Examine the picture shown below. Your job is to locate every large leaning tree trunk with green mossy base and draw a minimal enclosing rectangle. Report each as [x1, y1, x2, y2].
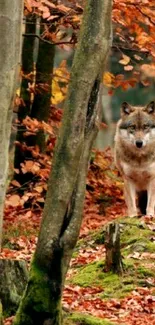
[14, 0, 112, 325]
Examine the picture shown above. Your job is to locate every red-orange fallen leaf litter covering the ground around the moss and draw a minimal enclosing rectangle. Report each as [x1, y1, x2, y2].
[0, 148, 155, 325]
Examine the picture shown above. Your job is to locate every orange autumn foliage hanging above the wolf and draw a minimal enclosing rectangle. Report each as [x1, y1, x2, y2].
[109, 0, 155, 90]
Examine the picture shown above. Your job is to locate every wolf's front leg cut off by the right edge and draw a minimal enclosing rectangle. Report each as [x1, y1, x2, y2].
[146, 180, 155, 216]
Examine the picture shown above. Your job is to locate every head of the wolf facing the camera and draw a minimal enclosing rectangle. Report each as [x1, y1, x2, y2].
[118, 102, 155, 150]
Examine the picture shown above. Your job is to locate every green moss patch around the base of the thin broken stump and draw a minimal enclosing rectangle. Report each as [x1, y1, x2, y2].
[70, 253, 155, 298]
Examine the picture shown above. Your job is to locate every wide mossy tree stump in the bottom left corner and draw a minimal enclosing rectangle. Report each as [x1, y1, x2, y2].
[0, 259, 28, 316]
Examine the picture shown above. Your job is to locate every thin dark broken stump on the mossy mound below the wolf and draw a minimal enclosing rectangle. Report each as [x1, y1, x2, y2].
[105, 222, 123, 274]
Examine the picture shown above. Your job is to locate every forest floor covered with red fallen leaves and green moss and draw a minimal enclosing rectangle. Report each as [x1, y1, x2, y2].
[0, 149, 155, 325]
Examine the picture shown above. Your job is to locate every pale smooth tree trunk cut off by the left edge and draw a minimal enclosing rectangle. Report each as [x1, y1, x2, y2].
[0, 0, 23, 246]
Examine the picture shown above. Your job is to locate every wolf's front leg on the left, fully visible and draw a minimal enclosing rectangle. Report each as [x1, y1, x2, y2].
[124, 179, 137, 217]
